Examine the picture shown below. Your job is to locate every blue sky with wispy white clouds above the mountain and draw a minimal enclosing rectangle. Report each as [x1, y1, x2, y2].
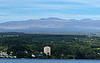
[0, 0, 100, 23]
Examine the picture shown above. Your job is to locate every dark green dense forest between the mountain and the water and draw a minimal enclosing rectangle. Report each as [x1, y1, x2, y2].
[0, 32, 100, 59]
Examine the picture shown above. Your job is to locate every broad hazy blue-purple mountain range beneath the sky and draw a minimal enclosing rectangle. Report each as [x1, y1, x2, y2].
[0, 17, 100, 33]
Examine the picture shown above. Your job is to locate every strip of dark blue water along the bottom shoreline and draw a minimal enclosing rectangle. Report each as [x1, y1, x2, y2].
[0, 59, 100, 63]
